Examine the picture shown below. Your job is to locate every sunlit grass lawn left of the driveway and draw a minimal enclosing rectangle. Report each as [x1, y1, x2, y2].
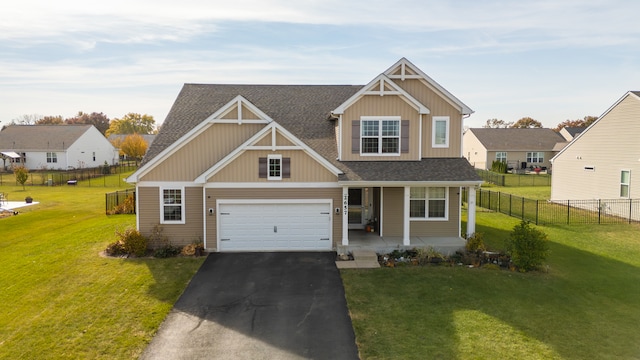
[0, 174, 204, 359]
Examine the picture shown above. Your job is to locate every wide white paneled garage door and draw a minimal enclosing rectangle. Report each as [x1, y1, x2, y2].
[218, 200, 332, 251]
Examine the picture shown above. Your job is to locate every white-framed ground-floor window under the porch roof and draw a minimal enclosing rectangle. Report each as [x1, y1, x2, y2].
[409, 187, 448, 220]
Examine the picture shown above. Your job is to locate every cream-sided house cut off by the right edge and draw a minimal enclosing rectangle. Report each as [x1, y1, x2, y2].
[551, 91, 640, 200]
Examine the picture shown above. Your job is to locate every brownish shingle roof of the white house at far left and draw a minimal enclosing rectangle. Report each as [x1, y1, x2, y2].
[0, 125, 93, 151]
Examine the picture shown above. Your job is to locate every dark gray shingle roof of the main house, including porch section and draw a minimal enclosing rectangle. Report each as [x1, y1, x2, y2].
[143, 84, 480, 181]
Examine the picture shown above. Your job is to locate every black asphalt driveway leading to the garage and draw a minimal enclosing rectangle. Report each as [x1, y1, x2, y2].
[141, 252, 358, 359]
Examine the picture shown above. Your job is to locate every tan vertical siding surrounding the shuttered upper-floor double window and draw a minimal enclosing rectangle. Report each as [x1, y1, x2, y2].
[342, 95, 420, 161]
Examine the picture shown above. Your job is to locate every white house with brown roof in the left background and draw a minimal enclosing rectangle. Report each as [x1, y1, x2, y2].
[0, 125, 118, 170]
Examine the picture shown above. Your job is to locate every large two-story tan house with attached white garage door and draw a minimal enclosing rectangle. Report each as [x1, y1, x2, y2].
[127, 58, 482, 251]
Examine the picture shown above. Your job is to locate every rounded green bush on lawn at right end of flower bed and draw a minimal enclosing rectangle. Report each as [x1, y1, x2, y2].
[505, 221, 549, 272]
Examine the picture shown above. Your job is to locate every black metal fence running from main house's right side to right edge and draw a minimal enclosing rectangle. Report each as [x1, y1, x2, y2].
[463, 189, 640, 225]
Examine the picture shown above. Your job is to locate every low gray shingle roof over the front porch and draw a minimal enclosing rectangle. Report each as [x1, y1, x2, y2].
[338, 158, 482, 184]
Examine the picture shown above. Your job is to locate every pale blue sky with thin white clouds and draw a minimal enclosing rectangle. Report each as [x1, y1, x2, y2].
[0, 0, 640, 127]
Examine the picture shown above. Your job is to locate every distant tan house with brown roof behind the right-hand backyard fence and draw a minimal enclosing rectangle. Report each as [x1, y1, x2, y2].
[462, 128, 564, 170]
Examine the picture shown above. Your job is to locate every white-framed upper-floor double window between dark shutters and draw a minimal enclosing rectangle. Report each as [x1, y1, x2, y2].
[360, 117, 400, 155]
